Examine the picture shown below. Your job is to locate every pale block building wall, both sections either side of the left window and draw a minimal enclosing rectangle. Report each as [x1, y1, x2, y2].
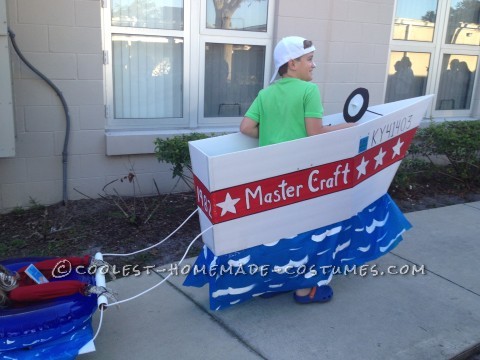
[0, 0, 402, 212]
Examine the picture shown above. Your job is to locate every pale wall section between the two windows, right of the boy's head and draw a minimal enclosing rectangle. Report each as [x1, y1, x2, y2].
[276, 0, 394, 114]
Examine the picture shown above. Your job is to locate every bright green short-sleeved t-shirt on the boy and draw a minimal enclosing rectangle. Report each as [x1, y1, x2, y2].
[245, 78, 323, 146]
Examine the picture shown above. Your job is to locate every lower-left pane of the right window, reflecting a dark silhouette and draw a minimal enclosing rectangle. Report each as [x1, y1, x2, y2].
[385, 51, 430, 102]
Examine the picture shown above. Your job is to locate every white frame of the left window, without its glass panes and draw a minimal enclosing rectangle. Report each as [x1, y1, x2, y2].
[102, 0, 275, 133]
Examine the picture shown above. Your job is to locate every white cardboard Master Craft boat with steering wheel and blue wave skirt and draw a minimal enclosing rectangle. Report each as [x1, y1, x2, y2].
[184, 93, 433, 310]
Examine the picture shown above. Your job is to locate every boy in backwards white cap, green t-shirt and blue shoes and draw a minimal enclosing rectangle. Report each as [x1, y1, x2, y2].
[240, 36, 353, 303]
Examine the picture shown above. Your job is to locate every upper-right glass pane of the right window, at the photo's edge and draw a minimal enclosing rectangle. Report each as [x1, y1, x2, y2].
[445, 0, 480, 46]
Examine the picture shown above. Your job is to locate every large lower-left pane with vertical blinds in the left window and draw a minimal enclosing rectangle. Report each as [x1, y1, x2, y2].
[112, 35, 183, 119]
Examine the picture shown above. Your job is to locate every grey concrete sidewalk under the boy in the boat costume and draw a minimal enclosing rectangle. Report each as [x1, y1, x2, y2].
[78, 202, 480, 360]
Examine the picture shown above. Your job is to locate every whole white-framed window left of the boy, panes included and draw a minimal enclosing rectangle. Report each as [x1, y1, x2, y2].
[103, 0, 274, 132]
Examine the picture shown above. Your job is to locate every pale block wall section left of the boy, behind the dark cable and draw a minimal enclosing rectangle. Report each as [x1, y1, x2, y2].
[0, 0, 182, 212]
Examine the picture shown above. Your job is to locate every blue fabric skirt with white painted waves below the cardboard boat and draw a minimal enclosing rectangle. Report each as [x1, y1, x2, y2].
[183, 194, 411, 310]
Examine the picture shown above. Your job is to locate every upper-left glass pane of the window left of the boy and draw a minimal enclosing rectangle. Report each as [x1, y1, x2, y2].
[112, 0, 183, 30]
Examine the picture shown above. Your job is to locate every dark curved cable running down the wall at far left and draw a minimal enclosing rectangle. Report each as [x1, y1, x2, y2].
[8, 28, 70, 205]
